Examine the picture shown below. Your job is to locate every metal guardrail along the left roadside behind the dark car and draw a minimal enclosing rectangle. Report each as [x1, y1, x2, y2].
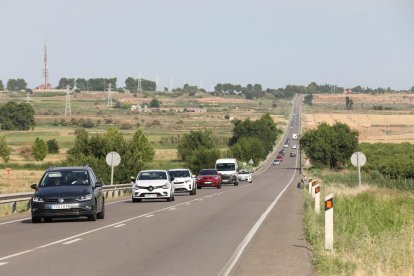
[0, 184, 132, 214]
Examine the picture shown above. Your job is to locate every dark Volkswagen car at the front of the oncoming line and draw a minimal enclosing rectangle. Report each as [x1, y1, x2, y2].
[30, 167, 105, 223]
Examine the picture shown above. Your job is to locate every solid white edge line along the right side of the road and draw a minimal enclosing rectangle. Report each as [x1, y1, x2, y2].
[219, 156, 298, 276]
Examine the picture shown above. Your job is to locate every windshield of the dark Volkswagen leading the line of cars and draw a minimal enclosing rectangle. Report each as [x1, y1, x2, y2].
[40, 170, 90, 187]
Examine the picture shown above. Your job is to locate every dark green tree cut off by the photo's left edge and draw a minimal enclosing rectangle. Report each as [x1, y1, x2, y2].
[0, 101, 35, 130]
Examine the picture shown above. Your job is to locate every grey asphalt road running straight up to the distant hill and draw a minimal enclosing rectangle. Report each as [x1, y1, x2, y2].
[0, 96, 311, 275]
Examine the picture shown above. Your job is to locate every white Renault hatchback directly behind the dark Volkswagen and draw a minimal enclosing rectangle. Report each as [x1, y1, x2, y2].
[131, 170, 175, 202]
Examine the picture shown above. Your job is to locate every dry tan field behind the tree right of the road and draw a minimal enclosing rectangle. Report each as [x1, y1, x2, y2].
[303, 94, 414, 143]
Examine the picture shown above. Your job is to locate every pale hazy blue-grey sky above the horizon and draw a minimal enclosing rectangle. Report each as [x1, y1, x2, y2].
[0, 0, 414, 90]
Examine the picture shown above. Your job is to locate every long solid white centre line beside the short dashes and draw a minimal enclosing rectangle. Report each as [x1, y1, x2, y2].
[0, 187, 251, 262]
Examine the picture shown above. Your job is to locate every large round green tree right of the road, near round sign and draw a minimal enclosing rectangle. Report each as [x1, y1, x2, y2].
[299, 122, 359, 169]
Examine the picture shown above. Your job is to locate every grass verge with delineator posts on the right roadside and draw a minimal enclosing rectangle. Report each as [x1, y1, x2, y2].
[305, 168, 414, 275]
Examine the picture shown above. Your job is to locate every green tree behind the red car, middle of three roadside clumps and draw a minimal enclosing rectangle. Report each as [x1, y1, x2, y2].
[177, 129, 216, 161]
